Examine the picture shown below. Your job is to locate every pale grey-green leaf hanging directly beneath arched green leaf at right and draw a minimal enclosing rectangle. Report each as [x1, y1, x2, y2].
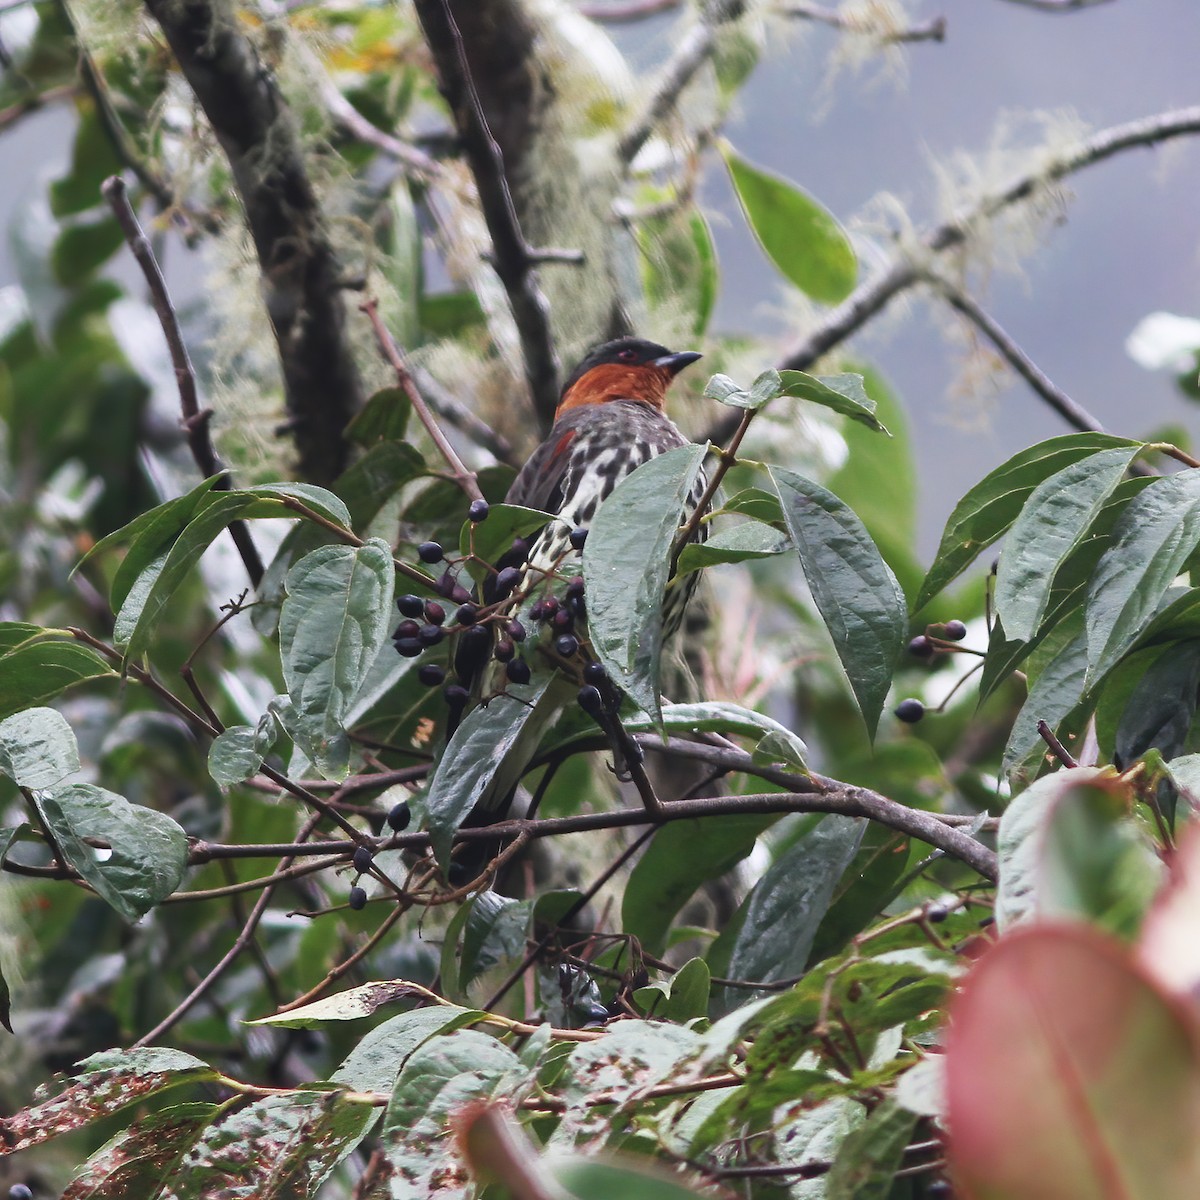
[995, 445, 1140, 641]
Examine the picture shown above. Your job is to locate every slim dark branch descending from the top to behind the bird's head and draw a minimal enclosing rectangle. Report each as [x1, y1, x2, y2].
[415, 0, 558, 424]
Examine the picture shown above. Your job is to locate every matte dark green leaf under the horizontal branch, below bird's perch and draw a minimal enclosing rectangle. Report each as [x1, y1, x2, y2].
[620, 814, 779, 955]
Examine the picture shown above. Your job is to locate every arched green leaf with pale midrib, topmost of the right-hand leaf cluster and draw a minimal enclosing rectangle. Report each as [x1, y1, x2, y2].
[914, 433, 1140, 610]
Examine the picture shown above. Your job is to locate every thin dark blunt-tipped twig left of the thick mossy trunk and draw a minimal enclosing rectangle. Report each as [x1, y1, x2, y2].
[100, 175, 263, 588]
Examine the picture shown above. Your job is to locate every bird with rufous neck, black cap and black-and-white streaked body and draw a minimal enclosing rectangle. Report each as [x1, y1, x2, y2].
[422, 337, 707, 866]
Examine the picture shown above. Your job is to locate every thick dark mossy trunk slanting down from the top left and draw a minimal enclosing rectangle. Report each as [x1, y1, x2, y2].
[145, 0, 362, 484]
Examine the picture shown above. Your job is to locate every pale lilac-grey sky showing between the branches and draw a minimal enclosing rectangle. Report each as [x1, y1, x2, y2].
[0, 0, 1200, 559]
